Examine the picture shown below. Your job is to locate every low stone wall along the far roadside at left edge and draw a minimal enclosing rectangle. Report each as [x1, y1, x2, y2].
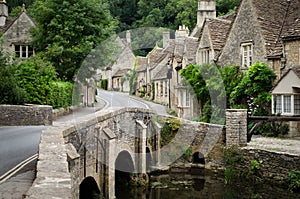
[0, 105, 53, 126]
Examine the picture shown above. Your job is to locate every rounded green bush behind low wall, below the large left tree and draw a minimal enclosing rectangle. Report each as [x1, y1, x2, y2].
[15, 57, 56, 105]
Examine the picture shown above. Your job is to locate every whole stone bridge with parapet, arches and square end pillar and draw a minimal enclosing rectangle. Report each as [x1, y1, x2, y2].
[27, 108, 247, 198]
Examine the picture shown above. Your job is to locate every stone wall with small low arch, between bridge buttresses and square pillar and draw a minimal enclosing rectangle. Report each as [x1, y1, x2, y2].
[161, 116, 225, 169]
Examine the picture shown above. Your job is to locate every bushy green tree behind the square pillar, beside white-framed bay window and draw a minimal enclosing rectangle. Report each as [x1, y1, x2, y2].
[230, 62, 276, 115]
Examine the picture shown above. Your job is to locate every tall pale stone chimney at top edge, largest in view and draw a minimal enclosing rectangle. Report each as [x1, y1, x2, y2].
[197, 0, 217, 27]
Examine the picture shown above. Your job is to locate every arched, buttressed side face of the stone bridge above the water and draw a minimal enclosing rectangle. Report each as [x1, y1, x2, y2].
[64, 108, 161, 198]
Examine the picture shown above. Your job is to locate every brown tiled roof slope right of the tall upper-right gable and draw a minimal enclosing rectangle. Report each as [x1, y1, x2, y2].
[252, 0, 300, 56]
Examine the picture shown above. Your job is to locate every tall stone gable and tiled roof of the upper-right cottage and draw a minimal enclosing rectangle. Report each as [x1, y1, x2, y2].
[217, 0, 300, 77]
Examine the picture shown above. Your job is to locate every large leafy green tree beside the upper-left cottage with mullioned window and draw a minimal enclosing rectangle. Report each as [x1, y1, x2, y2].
[32, 0, 116, 80]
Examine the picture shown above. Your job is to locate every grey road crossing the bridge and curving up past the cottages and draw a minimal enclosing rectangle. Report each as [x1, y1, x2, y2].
[0, 90, 165, 180]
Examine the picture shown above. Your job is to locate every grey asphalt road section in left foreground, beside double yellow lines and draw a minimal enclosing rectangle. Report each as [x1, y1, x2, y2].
[0, 126, 47, 176]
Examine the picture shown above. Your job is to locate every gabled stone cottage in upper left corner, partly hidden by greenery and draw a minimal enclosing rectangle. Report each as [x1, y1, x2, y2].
[0, 0, 36, 58]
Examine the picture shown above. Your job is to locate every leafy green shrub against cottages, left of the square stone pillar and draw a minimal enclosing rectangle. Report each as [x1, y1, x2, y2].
[180, 64, 226, 124]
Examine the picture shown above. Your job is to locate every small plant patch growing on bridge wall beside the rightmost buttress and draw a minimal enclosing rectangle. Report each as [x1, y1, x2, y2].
[160, 118, 180, 147]
